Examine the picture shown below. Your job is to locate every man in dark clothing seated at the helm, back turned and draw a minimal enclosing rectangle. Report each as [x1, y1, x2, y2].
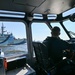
[43, 26, 71, 63]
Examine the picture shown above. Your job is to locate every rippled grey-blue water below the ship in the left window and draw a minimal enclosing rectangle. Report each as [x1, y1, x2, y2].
[0, 43, 27, 57]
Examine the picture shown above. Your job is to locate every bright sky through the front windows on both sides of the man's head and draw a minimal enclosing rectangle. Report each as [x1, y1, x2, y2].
[32, 20, 75, 41]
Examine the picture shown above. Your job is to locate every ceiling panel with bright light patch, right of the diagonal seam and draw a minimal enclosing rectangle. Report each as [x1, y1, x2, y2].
[33, 0, 75, 14]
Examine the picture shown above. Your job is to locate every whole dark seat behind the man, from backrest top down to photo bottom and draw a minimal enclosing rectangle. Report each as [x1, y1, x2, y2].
[33, 42, 55, 75]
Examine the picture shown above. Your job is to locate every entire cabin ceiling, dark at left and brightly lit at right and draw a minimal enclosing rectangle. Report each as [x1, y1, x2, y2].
[0, 0, 75, 14]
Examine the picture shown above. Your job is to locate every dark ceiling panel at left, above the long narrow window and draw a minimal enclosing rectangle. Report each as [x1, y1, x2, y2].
[0, 0, 35, 12]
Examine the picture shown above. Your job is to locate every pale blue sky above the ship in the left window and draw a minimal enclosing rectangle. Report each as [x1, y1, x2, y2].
[0, 21, 26, 38]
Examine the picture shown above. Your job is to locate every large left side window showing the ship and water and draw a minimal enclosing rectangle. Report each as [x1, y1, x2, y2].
[0, 21, 28, 58]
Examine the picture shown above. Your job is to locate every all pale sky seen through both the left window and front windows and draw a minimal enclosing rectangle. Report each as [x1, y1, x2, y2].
[0, 8, 75, 41]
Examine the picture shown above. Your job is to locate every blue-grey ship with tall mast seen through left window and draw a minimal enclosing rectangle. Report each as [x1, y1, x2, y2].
[0, 23, 26, 46]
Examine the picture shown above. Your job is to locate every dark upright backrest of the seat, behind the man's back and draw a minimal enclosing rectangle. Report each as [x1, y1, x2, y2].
[33, 42, 53, 70]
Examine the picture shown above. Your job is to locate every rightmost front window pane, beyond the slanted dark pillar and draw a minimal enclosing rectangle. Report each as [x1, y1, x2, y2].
[63, 20, 75, 38]
